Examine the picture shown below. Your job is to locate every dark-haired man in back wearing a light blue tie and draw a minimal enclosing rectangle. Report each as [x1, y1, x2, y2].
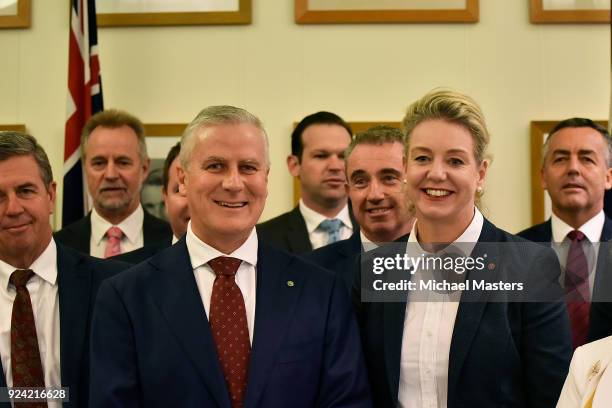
[257, 112, 357, 254]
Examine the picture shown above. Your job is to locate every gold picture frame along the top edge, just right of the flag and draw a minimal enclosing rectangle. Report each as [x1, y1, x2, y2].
[96, 0, 252, 27]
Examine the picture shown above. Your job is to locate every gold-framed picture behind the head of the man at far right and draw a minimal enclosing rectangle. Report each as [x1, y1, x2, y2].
[530, 120, 608, 225]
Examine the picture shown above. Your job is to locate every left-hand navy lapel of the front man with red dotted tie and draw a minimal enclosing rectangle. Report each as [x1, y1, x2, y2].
[149, 242, 231, 407]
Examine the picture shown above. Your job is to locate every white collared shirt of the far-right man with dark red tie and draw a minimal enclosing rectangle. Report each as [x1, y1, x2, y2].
[550, 210, 606, 295]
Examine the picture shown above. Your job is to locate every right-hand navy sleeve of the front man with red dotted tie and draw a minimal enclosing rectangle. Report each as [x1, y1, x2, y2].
[317, 276, 372, 408]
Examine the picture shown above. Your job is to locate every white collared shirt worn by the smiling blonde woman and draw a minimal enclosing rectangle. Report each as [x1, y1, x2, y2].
[398, 208, 484, 408]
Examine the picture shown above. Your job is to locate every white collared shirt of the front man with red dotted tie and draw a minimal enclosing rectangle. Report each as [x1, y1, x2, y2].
[186, 221, 259, 345]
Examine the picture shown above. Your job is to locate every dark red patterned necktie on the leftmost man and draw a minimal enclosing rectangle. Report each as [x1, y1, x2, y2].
[9, 269, 47, 408]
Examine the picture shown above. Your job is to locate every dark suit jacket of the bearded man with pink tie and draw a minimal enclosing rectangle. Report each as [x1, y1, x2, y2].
[53, 210, 172, 254]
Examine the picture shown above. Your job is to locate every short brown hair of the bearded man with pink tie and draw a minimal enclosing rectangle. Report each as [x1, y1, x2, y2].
[81, 109, 149, 163]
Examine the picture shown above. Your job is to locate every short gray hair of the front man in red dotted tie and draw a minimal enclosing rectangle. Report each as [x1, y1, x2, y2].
[179, 105, 270, 169]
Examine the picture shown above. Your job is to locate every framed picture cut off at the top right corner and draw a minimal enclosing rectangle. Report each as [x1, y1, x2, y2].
[530, 0, 610, 24]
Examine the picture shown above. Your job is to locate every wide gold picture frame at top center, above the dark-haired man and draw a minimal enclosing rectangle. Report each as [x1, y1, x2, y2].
[295, 0, 479, 24]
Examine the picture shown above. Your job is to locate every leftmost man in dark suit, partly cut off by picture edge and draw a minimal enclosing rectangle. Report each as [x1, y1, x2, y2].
[0, 132, 127, 407]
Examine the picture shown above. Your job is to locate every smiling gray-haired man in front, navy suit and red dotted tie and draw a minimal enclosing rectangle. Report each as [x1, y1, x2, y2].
[90, 106, 371, 408]
